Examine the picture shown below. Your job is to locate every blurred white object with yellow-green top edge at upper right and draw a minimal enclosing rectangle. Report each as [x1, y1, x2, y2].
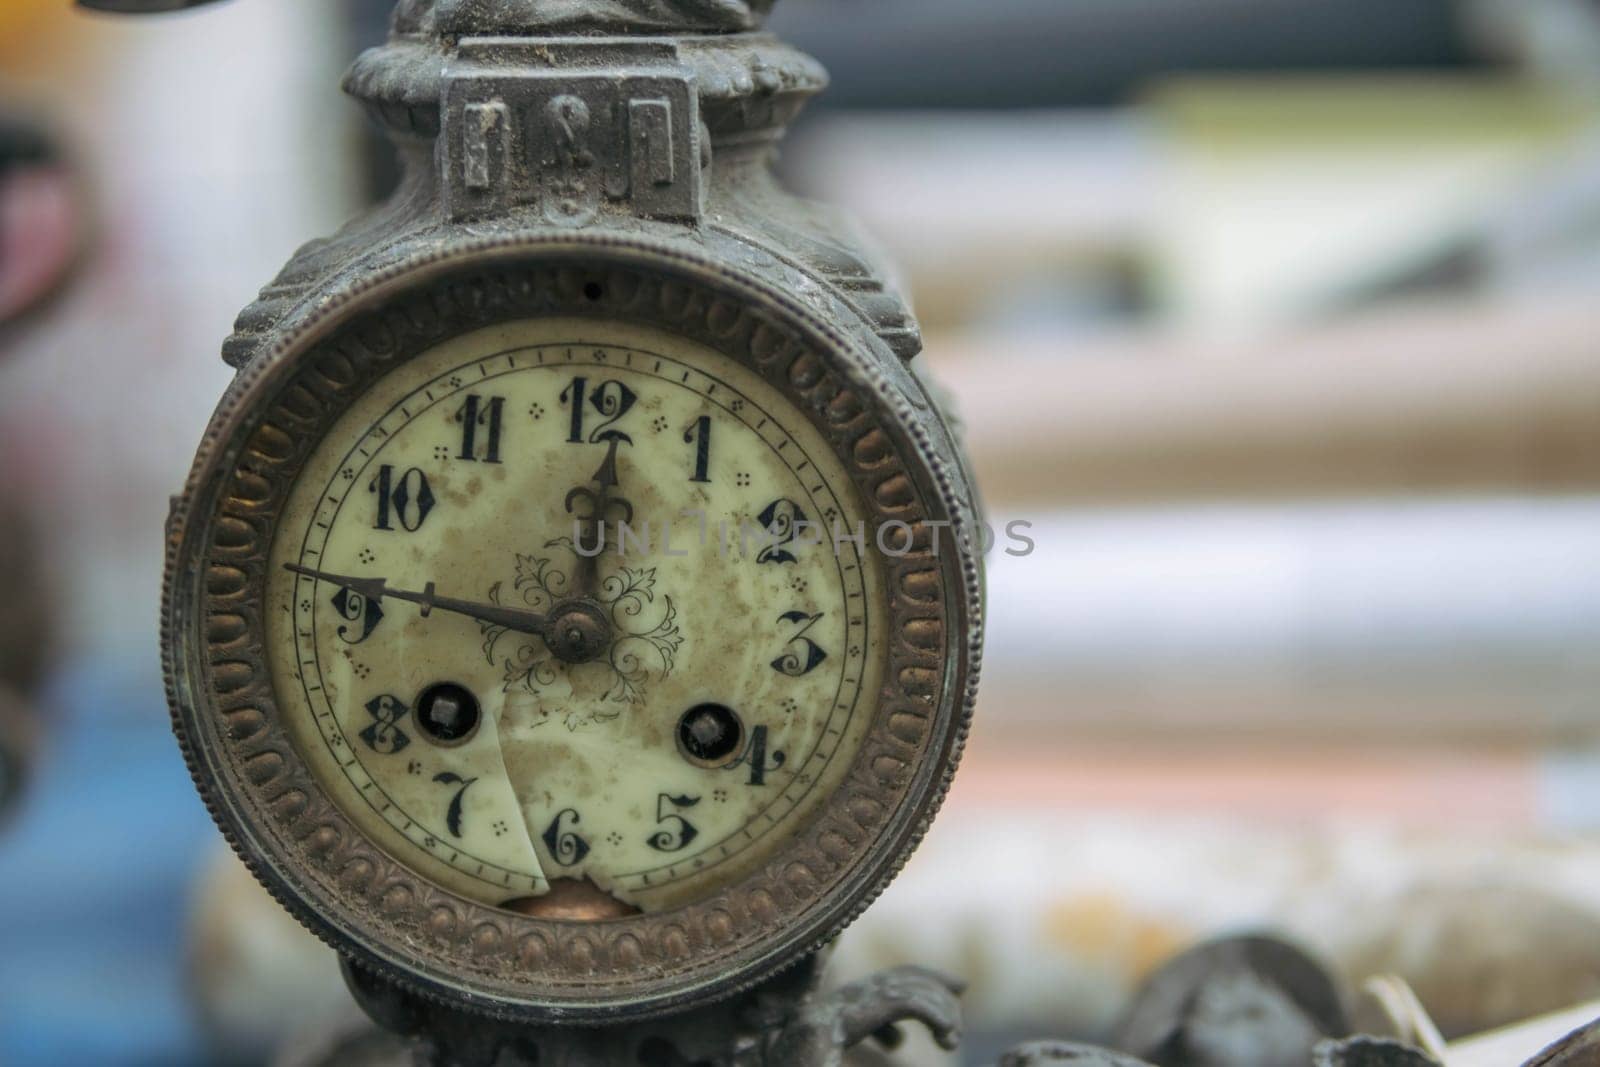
[1157, 75, 1597, 333]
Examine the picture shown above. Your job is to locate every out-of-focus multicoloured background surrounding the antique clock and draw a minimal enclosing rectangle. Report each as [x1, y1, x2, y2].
[0, 0, 1600, 1067]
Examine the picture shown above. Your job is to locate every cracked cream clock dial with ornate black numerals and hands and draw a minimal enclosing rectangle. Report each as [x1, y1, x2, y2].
[264, 318, 893, 918]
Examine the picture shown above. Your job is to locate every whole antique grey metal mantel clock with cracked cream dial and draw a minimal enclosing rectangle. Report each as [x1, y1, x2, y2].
[140, 0, 982, 1064]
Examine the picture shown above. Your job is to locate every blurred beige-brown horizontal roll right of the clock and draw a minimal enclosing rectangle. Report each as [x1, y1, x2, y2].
[928, 294, 1600, 507]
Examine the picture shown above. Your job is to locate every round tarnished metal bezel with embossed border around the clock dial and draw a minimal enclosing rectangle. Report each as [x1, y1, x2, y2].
[163, 232, 981, 1025]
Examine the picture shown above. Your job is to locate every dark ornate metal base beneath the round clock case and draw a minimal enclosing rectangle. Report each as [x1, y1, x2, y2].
[292, 955, 962, 1067]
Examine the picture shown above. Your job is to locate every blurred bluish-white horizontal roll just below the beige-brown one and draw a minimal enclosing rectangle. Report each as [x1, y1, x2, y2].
[981, 498, 1600, 751]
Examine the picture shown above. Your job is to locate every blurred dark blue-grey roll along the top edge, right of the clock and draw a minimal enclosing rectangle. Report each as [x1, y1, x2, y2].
[773, 0, 1483, 107]
